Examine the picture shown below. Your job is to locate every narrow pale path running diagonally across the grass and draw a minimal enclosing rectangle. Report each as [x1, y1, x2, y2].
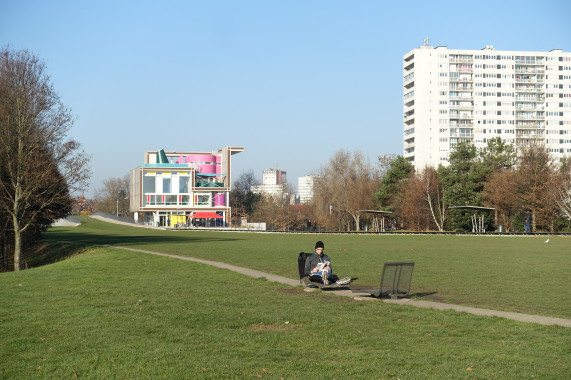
[108, 245, 571, 327]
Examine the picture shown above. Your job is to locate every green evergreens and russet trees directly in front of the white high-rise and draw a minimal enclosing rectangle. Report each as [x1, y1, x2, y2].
[382, 138, 571, 231]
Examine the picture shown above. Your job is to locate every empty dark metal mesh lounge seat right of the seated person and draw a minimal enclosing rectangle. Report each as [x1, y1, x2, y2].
[353, 261, 414, 299]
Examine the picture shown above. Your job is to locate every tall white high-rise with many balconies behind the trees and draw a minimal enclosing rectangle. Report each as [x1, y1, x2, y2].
[403, 41, 571, 169]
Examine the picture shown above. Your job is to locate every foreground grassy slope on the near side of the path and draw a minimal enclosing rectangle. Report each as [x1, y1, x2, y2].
[0, 248, 571, 379]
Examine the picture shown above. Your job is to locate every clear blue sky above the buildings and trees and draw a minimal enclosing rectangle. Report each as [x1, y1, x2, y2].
[0, 0, 571, 196]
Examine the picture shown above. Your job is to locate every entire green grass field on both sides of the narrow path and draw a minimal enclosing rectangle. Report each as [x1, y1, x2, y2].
[0, 219, 571, 379]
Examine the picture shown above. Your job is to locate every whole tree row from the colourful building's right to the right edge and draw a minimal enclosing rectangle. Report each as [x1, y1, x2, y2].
[231, 138, 571, 231]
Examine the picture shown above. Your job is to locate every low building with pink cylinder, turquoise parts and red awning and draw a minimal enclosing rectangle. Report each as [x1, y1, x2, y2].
[130, 147, 244, 227]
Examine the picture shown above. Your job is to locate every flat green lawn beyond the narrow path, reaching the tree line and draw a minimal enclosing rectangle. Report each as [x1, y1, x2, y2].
[42, 218, 571, 318]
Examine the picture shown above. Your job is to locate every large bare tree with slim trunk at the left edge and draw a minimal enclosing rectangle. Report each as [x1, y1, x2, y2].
[0, 48, 90, 270]
